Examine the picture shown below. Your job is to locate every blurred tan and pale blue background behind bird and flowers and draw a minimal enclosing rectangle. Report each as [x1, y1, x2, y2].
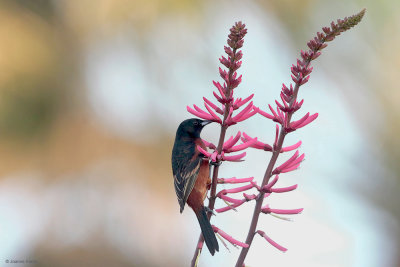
[0, 0, 400, 267]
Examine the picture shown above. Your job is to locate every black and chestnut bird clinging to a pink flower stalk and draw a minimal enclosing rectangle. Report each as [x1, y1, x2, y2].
[171, 118, 219, 255]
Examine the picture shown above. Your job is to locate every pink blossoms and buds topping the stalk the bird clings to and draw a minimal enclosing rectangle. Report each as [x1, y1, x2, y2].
[187, 22, 257, 162]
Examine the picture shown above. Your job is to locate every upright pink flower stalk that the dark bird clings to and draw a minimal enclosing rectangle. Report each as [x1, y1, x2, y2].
[187, 22, 257, 266]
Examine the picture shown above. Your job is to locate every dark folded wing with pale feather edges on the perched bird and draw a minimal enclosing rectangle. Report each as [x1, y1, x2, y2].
[174, 155, 202, 212]
